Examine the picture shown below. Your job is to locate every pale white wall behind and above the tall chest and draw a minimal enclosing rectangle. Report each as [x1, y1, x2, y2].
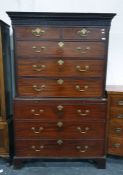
[0, 0, 123, 85]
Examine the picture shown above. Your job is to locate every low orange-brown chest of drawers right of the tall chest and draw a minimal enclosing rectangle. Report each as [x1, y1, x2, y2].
[107, 85, 123, 156]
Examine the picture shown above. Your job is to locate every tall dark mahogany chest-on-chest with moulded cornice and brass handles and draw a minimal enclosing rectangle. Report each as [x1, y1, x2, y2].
[8, 12, 115, 168]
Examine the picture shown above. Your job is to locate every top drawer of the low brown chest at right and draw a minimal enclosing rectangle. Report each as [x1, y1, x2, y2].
[110, 95, 123, 109]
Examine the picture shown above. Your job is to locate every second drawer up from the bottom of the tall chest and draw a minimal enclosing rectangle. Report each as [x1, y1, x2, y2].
[15, 120, 105, 139]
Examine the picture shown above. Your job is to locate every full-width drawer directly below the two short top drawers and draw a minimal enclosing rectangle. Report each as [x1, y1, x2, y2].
[16, 41, 106, 59]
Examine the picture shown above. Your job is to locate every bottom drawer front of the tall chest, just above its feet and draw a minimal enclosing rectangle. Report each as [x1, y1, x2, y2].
[15, 139, 104, 158]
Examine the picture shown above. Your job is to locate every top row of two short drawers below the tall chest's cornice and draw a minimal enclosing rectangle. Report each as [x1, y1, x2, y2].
[14, 25, 108, 40]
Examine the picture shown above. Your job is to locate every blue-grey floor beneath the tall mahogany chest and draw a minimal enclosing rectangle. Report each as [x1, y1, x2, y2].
[0, 157, 123, 175]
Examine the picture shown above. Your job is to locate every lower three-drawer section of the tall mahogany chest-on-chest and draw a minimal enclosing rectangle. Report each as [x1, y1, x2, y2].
[14, 98, 106, 157]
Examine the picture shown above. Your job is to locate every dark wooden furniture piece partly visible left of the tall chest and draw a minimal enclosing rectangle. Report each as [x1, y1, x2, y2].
[0, 20, 11, 157]
